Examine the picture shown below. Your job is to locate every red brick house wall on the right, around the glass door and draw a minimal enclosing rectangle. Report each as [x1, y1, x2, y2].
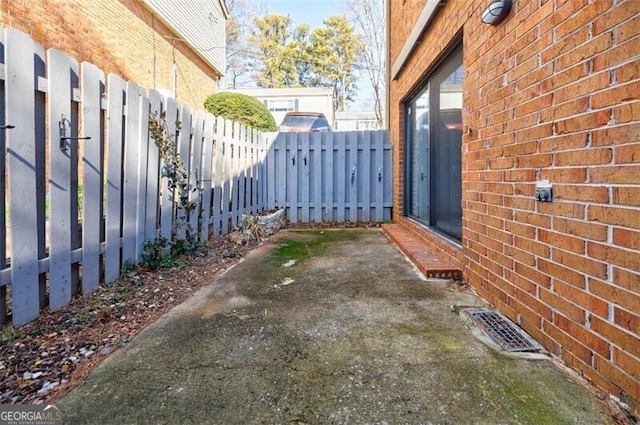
[389, 0, 640, 413]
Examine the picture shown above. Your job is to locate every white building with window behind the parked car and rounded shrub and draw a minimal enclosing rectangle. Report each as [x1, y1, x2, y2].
[229, 87, 335, 127]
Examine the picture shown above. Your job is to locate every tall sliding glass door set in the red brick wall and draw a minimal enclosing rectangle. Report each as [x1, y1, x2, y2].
[405, 47, 464, 241]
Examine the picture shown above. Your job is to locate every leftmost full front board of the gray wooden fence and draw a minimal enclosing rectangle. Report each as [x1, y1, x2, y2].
[5, 29, 40, 326]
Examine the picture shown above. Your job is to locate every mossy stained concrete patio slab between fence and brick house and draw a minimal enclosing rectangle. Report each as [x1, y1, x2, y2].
[58, 229, 607, 425]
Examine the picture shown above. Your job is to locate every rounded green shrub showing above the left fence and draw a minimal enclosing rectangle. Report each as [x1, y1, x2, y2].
[204, 92, 278, 131]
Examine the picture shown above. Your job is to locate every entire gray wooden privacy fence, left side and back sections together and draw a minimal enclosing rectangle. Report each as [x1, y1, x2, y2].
[0, 29, 391, 326]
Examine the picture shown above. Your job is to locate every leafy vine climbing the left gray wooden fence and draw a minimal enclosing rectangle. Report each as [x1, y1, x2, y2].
[142, 112, 205, 269]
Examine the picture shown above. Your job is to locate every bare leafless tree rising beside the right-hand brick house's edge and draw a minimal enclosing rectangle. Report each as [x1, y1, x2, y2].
[344, 0, 386, 127]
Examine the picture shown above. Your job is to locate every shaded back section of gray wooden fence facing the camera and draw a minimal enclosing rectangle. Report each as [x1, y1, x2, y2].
[266, 130, 392, 223]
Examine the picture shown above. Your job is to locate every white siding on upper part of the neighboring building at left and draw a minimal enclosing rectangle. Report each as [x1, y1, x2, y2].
[142, 0, 228, 75]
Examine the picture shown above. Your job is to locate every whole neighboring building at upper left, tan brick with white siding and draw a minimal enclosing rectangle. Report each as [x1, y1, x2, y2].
[0, 0, 228, 108]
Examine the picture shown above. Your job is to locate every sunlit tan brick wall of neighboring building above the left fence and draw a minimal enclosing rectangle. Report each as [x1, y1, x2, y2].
[0, 0, 218, 107]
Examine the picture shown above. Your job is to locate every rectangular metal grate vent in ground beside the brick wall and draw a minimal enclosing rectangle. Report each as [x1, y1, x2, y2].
[465, 309, 542, 352]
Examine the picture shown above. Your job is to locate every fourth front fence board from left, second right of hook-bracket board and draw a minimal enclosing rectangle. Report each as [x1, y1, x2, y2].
[105, 74, 125, 283]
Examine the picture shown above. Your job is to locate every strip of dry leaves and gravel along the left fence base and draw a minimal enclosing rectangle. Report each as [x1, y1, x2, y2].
[0, 238, 257, 404]
